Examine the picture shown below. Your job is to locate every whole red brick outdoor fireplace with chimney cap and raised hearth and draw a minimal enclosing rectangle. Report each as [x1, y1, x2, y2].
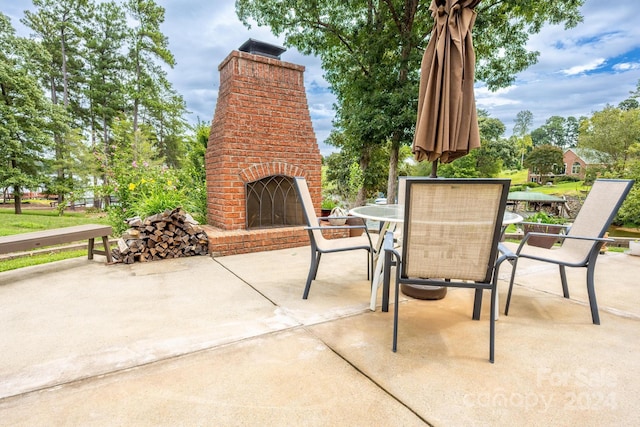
[205, 40, 321, 256]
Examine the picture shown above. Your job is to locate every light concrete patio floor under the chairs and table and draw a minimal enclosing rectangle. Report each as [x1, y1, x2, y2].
[0, 239, 640, 426]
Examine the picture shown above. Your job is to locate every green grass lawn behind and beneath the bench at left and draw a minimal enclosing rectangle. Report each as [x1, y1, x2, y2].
[0, 206, 109, 272]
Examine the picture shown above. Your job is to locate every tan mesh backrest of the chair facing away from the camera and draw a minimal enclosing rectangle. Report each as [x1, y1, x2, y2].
[401, 178, 510, 283]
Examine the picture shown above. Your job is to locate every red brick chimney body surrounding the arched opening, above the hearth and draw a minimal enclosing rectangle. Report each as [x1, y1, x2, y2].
[205, 51, 322, 256]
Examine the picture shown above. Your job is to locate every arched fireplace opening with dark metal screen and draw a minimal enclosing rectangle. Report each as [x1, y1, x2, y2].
[245, 175, 305, 230]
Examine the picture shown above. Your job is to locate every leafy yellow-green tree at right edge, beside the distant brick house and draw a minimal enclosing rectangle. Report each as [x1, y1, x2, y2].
[578, 106, 640, 175]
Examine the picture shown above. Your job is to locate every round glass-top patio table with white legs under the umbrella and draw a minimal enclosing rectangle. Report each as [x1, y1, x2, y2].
[349, 204, 523, 311]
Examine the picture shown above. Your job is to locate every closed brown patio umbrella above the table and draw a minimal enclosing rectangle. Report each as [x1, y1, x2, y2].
[413, 0, 480, 177]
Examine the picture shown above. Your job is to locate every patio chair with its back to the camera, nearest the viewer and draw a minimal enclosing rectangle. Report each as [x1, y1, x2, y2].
[384, 178, 510, 363]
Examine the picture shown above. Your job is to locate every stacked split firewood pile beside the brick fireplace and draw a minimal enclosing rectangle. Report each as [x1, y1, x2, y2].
[112, 208, 209, 264]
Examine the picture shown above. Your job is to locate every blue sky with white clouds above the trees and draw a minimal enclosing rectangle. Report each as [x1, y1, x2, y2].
[0, 0, 640, 154]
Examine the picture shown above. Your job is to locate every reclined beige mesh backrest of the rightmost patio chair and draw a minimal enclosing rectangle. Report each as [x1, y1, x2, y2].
[562, 179, 633, 256]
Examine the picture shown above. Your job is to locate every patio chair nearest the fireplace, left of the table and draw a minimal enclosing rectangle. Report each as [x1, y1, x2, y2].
[294, 177, 374, 299]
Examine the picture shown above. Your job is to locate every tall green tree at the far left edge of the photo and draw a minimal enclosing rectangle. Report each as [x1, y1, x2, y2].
[0, 13, 54, 214]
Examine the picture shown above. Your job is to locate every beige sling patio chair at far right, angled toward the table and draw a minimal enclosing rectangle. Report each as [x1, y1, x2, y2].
[504, 179, 633, 325]
